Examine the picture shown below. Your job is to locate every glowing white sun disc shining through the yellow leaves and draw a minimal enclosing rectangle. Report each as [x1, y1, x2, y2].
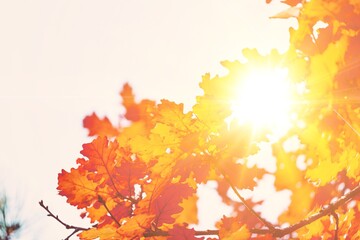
[232, 68, 291, 135]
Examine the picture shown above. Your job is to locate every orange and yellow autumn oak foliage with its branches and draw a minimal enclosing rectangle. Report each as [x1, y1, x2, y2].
[41, 0, 360, 239]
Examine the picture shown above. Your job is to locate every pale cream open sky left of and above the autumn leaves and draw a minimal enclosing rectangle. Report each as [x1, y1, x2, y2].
[0, 0, 294, 240]
